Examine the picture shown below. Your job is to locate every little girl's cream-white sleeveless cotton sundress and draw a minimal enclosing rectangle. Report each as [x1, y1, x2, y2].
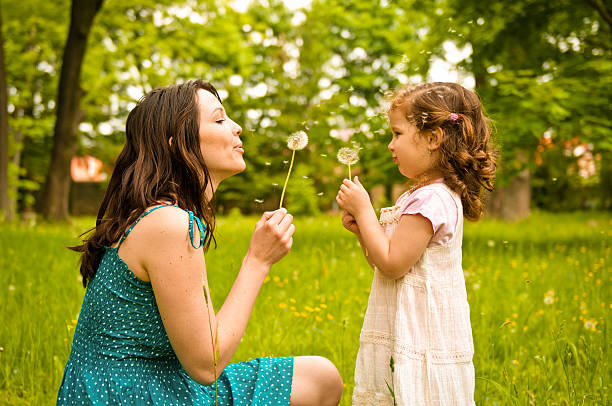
[353, 183, 475, 406]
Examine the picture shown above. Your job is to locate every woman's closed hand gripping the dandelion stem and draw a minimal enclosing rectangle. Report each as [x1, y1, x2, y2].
[246, 208, 295, 269]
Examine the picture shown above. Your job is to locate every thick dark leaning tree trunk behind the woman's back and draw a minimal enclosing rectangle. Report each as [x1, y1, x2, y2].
[40, 0, 104, 220]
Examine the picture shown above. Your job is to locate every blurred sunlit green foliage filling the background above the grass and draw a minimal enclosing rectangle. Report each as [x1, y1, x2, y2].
[3, 0, 612, 216]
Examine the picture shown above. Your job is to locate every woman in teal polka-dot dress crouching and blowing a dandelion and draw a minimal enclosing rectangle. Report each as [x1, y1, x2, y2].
[57, 80, 342, 405]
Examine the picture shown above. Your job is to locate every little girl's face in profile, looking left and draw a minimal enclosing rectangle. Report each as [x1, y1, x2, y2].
[387, 108, 434, 179]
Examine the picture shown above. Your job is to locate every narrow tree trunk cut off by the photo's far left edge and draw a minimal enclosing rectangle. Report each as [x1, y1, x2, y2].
[0, 5, 15, 221]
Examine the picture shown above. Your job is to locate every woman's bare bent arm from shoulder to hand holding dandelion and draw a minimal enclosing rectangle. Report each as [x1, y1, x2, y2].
[134, 207, 295, 385]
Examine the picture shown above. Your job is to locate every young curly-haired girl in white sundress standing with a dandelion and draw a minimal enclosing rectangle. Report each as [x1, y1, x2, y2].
[336, 83, 495, 406]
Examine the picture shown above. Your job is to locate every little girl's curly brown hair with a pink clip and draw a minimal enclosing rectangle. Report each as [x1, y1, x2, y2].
[389, 82, 497, 221]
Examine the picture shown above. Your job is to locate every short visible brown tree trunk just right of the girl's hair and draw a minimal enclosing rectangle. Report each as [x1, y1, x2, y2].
[486, 169, 531, 221]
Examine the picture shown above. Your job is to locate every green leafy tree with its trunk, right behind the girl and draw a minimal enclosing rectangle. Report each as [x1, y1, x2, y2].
[439, 0, 612, 219]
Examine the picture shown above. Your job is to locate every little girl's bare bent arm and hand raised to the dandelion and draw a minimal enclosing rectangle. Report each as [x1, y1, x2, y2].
[336, 177, 433, 279]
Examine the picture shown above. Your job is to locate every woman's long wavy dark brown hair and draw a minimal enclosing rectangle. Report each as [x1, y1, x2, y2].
[70, 80, 221, 287]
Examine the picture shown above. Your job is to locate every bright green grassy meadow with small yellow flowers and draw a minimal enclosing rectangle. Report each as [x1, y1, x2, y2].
[0, 213, 612, 405]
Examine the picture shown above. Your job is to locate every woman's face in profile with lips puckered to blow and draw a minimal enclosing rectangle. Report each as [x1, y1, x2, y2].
[196, 89, 246, 184]
